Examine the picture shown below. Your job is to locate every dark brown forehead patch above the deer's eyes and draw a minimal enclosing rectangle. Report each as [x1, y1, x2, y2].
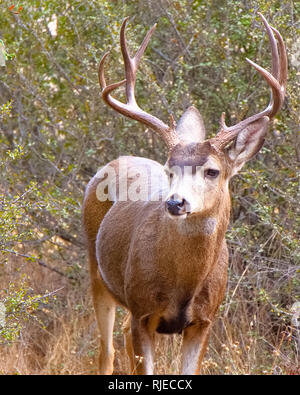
[168, 141, 214, 167]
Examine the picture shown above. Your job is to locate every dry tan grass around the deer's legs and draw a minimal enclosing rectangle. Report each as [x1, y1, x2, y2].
[0, 252, 299, 375]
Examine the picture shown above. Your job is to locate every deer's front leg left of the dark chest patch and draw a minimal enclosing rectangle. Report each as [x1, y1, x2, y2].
[131, 317, 155, 374]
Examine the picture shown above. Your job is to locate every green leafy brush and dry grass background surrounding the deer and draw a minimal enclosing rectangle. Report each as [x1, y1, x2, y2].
[0, 0, 300, 374]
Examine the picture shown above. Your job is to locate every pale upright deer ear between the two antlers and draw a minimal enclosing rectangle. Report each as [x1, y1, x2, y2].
[176, 106, 205, 143]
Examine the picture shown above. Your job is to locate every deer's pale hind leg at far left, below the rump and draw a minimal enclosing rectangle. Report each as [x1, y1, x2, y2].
[90, 258, 116, 374]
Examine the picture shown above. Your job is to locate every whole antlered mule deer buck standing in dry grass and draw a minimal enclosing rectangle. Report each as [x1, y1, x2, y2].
[83, 14, 287, 374]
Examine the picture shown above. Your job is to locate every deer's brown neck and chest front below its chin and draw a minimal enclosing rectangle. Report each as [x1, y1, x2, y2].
[157, 201, 230, 295]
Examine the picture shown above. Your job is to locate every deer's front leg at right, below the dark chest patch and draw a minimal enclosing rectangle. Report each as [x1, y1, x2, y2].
[181, 319, 211, 374]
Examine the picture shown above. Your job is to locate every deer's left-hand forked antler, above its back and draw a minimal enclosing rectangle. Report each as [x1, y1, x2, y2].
[98, 17, 179, 148]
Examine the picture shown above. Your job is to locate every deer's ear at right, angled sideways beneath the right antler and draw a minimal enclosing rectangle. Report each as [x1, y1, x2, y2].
[227, 117, 269, 176]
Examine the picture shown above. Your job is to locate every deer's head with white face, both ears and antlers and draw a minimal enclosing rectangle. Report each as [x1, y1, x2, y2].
[98, 13, 287, 218]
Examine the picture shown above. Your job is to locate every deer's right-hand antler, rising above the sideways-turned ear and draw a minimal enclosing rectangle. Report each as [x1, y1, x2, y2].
[212, 13, 287, 150]
